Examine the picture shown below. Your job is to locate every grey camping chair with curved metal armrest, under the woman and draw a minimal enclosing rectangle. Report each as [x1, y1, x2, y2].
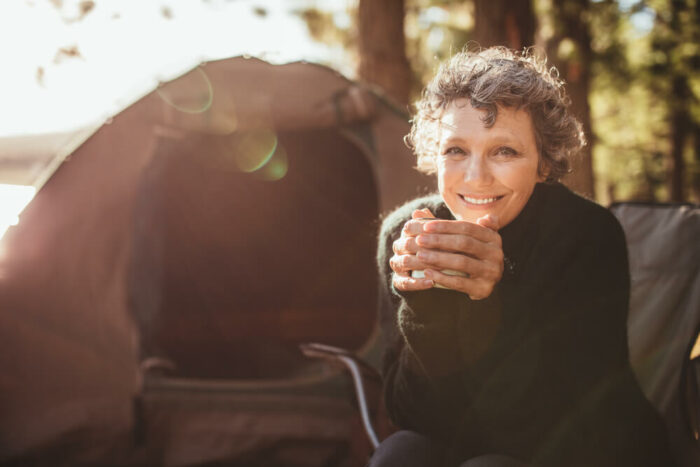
[301, 202, 700, 467]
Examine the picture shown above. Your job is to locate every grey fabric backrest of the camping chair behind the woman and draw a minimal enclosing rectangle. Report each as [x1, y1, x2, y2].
[611, 203, 700, 466]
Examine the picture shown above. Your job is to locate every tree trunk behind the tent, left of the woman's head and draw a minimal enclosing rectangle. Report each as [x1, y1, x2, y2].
[358, 0, 412, 105]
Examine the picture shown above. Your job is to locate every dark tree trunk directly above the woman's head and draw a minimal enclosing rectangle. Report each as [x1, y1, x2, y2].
[474, 0, 536, 50]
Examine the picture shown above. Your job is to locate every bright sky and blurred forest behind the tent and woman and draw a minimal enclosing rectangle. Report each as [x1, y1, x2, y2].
[0, 0, 700, 238]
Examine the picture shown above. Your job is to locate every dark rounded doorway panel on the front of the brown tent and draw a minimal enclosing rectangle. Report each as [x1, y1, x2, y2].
[130, 129, 379, 379]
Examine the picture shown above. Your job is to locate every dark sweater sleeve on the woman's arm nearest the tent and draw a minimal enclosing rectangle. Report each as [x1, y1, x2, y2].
[377, 203, 498, 439]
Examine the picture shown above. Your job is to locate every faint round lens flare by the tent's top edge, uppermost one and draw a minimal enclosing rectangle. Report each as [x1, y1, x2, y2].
[156, 67, 214, 114]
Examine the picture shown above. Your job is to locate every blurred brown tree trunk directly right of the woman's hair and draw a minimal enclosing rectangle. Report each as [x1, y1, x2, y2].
[547, 0, 595, 197]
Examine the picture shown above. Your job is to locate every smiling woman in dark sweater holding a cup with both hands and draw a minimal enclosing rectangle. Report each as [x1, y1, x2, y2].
[370, 48, 672, 467]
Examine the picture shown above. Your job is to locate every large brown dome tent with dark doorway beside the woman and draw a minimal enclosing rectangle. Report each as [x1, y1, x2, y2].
[0, 58, 433, 466]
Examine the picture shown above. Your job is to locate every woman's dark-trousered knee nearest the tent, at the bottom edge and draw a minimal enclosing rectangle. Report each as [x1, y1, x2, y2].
[368, 430, 439, 467]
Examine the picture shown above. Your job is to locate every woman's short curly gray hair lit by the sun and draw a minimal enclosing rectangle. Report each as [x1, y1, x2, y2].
[405, 47, 586, 181]
